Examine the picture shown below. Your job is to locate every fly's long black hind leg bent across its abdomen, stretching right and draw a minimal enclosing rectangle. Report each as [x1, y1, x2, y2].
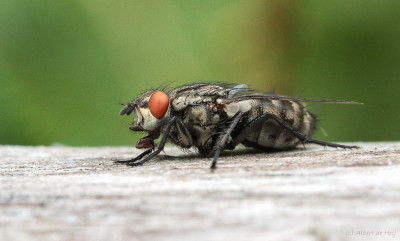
[230, 113, 359, 151]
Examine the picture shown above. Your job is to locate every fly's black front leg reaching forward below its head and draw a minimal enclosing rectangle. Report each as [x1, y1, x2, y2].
[117, 118, 175, 166]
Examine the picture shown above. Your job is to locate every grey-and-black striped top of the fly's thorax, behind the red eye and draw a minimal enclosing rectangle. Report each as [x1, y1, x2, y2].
[168, 83, 249, 111]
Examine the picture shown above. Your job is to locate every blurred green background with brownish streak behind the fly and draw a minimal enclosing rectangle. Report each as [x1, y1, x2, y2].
[0, 0, 400, 146]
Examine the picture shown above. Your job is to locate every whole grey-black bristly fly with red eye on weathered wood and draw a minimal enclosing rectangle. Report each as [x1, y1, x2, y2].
[118, 83, 361, 169]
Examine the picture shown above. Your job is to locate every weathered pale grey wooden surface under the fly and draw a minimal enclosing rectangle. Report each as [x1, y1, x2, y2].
[0, 143, 400, 241]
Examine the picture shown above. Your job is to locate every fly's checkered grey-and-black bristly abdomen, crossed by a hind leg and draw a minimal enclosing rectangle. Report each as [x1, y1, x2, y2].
[244, 100, 314, 149]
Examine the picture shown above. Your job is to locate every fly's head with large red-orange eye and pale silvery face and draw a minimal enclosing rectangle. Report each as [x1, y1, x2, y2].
[120, 90, 170, 148]
